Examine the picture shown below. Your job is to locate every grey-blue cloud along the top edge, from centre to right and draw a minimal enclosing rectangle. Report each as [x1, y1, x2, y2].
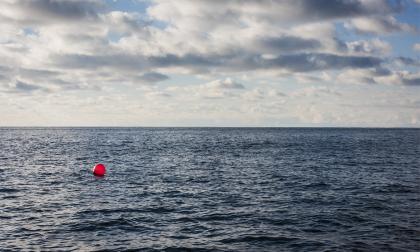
[150, 0, 402, 27]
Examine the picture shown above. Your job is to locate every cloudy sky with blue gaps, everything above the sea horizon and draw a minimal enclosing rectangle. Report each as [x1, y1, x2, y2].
[0, 0, 420, 127]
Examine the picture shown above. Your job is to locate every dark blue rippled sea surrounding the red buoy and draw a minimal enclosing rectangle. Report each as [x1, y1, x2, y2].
[0, 128, 420, 251]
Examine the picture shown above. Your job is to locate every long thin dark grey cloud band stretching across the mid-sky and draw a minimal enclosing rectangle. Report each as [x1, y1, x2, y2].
[53, 53, 382, 72]
